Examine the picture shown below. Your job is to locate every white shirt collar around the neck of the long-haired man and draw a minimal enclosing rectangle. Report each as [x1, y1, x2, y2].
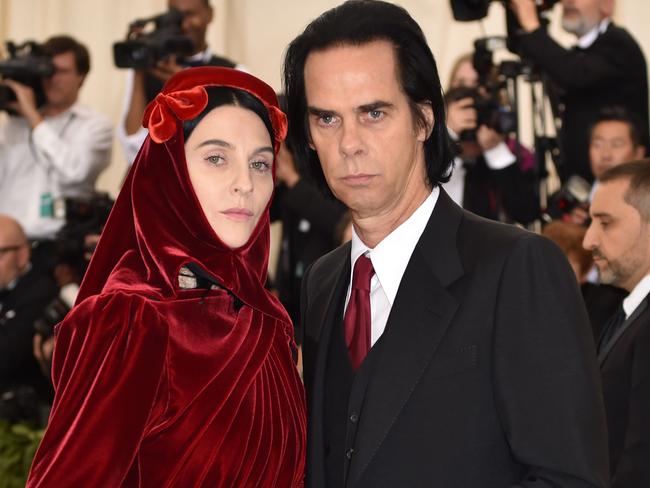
[350, 187, 440, 305]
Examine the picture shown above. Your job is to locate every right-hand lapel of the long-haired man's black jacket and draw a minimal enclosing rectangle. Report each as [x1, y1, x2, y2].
[347, 190, 463, 487]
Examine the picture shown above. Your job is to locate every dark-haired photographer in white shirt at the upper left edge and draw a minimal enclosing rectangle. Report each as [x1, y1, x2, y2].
[0, 36, 112, 254]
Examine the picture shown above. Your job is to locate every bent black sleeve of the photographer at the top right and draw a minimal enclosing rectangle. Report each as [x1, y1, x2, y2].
[521, 27, 630, 90]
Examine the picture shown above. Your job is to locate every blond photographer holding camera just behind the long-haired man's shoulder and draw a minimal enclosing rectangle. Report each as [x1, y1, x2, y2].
[443, 54, 539, 224]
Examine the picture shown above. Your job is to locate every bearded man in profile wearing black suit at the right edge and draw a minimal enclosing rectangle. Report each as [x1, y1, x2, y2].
[583, 159, 650, 488]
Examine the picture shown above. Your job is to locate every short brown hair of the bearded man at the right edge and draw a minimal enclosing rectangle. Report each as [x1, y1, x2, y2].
[598, 158, 650, 222]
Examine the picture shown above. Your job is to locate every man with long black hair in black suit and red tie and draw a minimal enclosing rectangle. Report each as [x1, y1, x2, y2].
[285, 0, 608, 488]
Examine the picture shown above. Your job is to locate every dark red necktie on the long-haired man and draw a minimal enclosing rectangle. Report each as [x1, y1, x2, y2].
[343, 256, 375, 371]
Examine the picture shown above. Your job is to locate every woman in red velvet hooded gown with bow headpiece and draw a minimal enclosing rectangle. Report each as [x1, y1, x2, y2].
[27, 67, 305, 488]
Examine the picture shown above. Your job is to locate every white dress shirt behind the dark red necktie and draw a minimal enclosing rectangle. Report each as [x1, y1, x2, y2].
[345, 187, 440, 346]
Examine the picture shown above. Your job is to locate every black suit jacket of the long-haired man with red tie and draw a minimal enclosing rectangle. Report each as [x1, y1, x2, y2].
[302, 190, 609, 488]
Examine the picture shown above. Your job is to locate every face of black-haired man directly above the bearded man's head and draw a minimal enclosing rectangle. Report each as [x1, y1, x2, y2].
[589, 120, 644, 179]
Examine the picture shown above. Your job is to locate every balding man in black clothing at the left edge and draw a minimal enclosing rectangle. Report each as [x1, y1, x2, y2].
[0, 215, 57, 421]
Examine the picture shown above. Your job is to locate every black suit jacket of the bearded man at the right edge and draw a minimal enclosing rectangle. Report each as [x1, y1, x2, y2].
[598, 297, 650, 488]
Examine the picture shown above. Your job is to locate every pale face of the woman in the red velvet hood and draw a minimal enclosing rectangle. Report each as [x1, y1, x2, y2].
[185, 105, 273, 249]
